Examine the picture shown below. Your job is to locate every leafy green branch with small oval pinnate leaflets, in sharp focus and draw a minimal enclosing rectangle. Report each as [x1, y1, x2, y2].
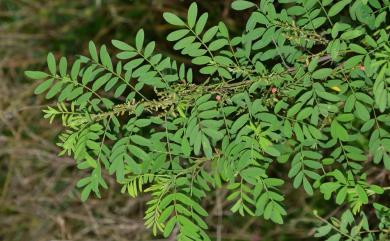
[26, 0, 390, 240]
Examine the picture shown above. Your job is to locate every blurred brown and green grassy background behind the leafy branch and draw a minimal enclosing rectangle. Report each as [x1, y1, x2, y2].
[0, 0, 331, 241]
